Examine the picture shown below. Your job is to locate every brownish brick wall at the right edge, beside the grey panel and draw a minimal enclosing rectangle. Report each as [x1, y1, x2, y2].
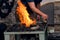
[54, 2, 60, 31]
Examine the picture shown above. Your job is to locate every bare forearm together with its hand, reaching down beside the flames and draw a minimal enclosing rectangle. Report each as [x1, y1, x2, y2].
[28, 2, 48, 19]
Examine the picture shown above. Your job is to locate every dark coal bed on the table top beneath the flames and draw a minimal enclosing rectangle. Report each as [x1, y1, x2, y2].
[6, 22, 46, 32]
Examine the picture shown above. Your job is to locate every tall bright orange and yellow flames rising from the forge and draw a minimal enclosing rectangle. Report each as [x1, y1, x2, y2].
[16, 0, 36, 27]
